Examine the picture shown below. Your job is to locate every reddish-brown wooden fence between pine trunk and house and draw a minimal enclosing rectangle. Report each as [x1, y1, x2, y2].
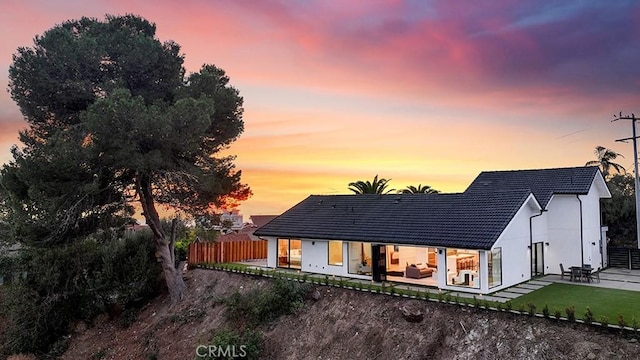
[188, 240, 267, 265]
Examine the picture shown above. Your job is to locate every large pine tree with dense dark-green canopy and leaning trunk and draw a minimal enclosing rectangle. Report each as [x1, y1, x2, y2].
[0, 15, 251, 299]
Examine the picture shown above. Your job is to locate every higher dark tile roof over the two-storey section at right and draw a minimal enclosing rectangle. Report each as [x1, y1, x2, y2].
[465, 166, 600, 208]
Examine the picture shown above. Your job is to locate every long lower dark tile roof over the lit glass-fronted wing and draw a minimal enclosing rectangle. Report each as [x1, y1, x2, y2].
[254, 190, 531, 249]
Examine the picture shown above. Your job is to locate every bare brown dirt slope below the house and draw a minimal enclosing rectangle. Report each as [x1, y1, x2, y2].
[58, 270, 640, 359]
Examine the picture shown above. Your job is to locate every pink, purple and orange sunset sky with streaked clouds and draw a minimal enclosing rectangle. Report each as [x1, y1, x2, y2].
[0, 0, 640, 219]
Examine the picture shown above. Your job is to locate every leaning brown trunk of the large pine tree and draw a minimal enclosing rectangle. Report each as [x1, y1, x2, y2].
[136, 175, 187, 305]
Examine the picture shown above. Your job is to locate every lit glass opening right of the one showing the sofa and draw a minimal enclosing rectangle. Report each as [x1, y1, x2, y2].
[446, 249, 480, 289]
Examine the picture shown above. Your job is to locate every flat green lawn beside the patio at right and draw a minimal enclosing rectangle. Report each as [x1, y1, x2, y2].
[512, 283, 640, 324]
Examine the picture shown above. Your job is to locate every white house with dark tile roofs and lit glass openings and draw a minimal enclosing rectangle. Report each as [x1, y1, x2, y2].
[254, 167, 611, 294]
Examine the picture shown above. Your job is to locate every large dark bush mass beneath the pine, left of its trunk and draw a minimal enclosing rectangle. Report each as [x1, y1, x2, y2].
[0, 233, 161, 353]
